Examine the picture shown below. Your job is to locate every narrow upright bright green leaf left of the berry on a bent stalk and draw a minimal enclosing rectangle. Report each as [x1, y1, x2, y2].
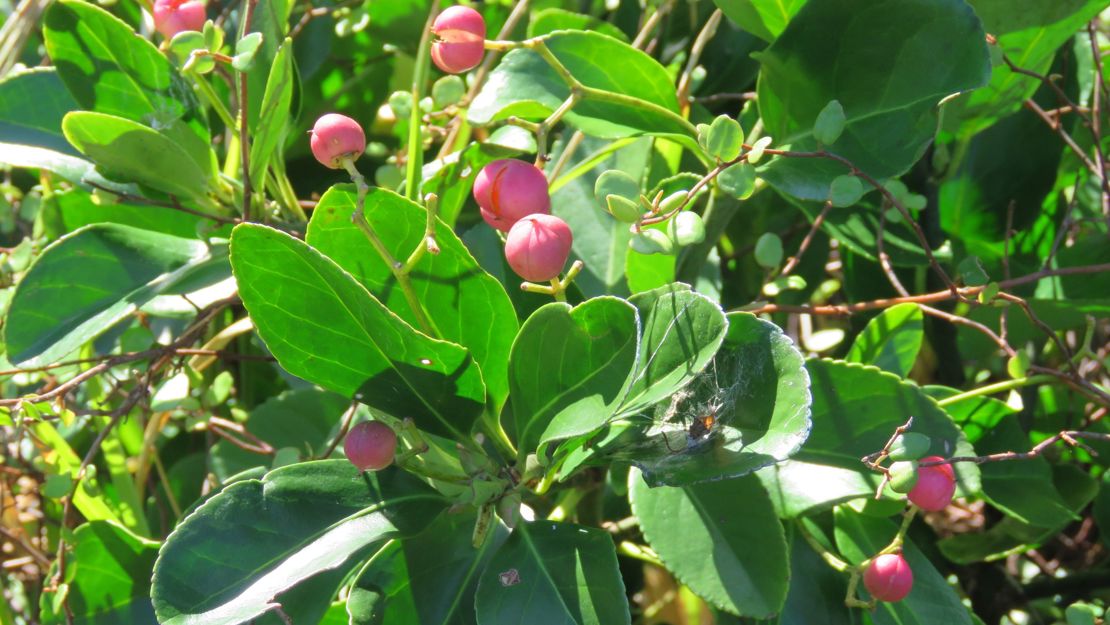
[251, 38, 296, 192]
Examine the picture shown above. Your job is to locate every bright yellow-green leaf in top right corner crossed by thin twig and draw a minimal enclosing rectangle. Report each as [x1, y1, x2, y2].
[945, 0, 1106, 138]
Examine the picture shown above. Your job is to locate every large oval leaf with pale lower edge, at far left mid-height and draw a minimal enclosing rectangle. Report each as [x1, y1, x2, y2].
[3, 223, 226, 366]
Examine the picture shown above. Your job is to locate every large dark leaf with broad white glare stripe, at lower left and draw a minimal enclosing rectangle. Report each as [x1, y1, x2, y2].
[151, 460, 446, 625]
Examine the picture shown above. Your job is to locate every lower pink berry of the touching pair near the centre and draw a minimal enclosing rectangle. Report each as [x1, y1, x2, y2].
[505, 213, 573, 282]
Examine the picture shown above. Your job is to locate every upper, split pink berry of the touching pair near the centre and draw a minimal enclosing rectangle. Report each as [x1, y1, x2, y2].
[474, 159, 552, 232]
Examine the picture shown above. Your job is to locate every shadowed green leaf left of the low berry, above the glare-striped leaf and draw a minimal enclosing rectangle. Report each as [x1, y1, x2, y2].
[208, 389, 350, 483]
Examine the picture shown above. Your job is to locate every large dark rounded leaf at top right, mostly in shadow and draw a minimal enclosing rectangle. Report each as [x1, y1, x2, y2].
[758, 0, 990, 201]
